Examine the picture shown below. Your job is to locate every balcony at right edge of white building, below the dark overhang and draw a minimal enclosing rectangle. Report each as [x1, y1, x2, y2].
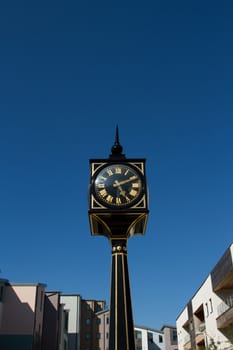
[217, 295, 233, 329]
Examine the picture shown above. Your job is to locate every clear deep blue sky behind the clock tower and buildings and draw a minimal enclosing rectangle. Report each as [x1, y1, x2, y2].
[0, 0, 233, 329]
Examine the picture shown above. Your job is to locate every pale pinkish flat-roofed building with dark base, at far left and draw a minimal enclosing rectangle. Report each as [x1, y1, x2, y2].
[0, 280, 45, 350]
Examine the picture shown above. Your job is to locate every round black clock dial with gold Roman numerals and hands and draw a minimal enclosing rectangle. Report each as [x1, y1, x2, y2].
[94, 164, 142, 208]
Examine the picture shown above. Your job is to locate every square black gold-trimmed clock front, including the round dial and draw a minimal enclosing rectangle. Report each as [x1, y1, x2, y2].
[90, 159, 147, 212]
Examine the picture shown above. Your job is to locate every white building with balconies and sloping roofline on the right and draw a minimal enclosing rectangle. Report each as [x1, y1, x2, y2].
[176, 244, 233, 350]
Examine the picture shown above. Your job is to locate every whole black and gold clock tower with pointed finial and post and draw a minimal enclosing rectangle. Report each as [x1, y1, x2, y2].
[89, 127, 149, 350]
